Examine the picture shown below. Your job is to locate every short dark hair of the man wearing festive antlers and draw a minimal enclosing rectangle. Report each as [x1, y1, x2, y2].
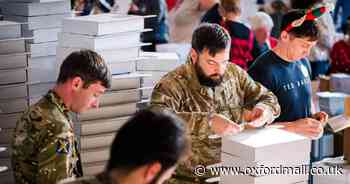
[281, 10, 319, 41]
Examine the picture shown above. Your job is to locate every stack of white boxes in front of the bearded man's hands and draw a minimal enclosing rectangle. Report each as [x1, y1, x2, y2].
[220, 128, 311, 184]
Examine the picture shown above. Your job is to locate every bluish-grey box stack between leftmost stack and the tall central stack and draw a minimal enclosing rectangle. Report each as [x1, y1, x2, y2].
[1, 0, 71, 105]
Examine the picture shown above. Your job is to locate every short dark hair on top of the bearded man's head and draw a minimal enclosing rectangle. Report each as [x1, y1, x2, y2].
[192, 23, 231, 56]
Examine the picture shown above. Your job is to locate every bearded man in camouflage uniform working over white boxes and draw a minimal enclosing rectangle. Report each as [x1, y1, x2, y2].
[151, 24, 280, 184]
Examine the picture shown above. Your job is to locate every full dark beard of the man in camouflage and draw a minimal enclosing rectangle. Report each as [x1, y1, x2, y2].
[194, 62, 223, 87]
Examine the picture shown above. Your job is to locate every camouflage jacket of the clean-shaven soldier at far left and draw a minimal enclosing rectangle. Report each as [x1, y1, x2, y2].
[12, 91, 82, 184]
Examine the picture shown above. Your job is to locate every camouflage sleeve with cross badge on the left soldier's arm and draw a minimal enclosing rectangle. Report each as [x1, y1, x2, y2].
[37, 116, 75, 184]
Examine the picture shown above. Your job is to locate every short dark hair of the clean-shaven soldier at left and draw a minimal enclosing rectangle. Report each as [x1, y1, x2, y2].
[57, 50, 112, 88]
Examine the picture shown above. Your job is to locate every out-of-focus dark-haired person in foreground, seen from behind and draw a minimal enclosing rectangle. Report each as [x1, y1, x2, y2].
[59, 110, 190, 184]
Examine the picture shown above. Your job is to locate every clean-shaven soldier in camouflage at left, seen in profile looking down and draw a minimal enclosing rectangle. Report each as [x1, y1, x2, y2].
[12, 50, 111, 184]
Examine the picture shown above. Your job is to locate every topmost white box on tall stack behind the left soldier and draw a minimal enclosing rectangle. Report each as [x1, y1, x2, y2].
[63, 14, 144, 36]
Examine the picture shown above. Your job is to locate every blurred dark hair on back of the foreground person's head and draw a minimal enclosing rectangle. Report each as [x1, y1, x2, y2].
[107, 109, 189, 171]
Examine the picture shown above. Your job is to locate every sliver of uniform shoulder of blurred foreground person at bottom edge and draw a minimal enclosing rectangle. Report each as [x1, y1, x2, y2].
[58, 172, 111, 184]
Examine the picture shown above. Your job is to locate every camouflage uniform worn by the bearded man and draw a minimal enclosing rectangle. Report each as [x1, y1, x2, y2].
[151, 59, 280, 184]
